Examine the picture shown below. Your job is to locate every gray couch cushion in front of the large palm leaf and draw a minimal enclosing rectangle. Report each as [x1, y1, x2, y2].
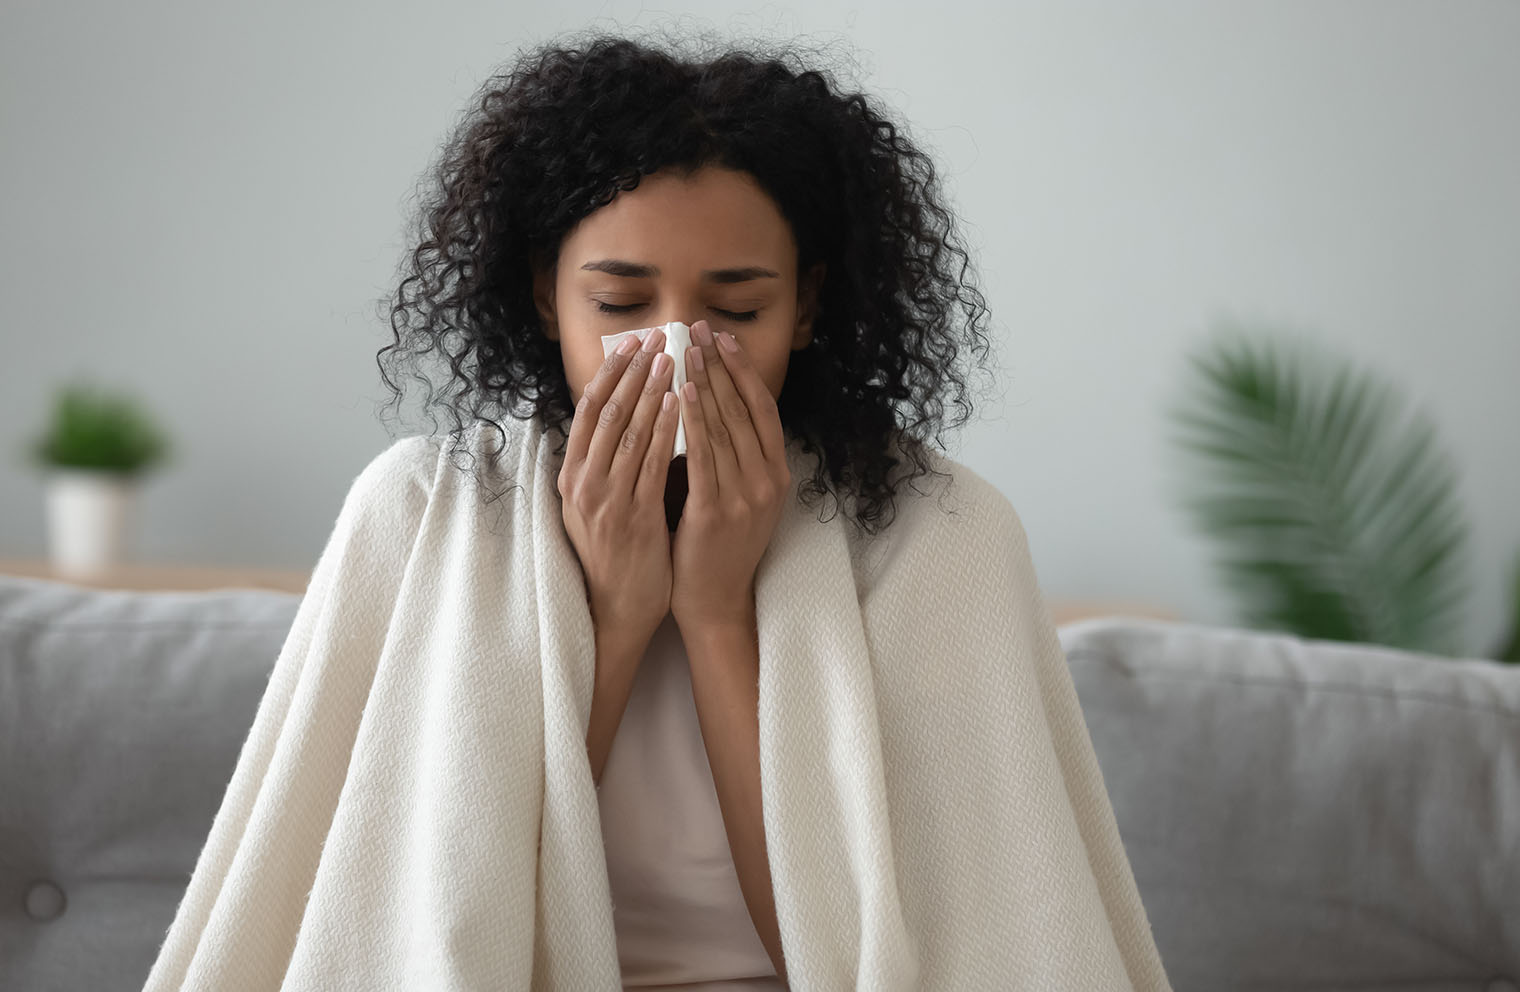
[1059, 617, 1520, 992]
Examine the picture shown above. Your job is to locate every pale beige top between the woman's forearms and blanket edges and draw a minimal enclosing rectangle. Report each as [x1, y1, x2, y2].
[597, 615, 786, 992]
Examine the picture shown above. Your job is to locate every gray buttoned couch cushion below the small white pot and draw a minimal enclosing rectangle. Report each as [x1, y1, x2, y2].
[0, 576, 299, 992]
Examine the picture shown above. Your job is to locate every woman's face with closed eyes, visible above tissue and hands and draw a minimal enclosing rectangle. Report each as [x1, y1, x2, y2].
[534, 167, 822, 403]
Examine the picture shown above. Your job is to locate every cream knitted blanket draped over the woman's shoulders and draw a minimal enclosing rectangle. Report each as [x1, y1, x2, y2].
[146, 419, 1170, 992]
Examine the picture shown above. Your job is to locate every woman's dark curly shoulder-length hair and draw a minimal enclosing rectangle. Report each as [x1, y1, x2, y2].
[375, 35, 988, 533]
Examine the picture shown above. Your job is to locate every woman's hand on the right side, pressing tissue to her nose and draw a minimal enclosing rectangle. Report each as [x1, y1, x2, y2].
[670, 321, 792, 630]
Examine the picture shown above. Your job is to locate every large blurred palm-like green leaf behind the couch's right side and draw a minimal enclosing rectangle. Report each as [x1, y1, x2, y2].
[1172, 320, 1468, 653]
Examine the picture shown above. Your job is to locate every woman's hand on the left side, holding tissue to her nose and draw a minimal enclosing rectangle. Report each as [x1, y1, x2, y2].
[558, 330, 681, 637]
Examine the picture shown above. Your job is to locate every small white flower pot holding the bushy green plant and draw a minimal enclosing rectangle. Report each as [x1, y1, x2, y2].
[47, 468, 137, 574]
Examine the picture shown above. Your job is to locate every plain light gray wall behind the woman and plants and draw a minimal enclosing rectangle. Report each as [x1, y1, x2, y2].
[0, 0, 1520, 650]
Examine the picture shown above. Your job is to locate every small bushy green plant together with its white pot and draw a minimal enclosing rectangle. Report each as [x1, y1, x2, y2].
[30, 383, 169, 573]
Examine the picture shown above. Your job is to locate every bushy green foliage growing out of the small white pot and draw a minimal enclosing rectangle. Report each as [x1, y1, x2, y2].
[30, 383, 169, 475]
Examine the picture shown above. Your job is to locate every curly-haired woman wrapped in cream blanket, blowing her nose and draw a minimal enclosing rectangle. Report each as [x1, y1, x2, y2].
[149, 27, 1166, 990]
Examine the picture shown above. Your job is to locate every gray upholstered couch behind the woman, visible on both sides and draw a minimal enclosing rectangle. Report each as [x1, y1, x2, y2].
[0, 577, 1520, 992]
